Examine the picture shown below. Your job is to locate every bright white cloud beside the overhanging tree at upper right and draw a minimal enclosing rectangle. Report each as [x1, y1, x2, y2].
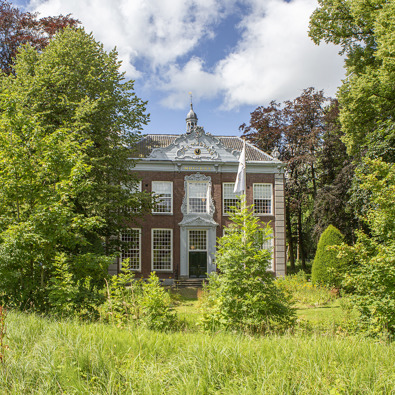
[216, 0, 343, 108]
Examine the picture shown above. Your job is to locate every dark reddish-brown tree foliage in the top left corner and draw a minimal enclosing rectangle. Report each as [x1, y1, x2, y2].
[0, 0, 80, 74]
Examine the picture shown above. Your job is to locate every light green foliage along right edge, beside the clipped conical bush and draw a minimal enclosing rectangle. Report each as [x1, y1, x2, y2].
[341, 159, 395, 335]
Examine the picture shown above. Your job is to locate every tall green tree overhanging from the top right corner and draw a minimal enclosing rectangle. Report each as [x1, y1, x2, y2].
[309, 0, 395, 162]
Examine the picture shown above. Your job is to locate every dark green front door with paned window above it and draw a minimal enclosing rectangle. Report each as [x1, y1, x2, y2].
[188, 230, 207, 278]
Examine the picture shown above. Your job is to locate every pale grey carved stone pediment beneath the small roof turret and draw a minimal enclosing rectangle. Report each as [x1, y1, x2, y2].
[148, 126, 240, 162]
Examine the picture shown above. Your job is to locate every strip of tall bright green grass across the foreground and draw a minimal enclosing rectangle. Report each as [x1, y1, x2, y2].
[0, 312, 395, 394]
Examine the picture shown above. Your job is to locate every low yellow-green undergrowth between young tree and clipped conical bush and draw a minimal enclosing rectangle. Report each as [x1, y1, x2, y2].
[275, 270, 335, 308]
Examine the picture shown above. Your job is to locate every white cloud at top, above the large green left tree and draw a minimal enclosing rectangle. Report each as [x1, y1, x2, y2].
[30, 0, 238, 77]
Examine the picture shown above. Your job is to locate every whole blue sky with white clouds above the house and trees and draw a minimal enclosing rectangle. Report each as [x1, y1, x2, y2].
[10, 0, 344, 136]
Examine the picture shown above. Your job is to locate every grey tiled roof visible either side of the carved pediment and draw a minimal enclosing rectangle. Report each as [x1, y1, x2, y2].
[137, 134, 275, 162]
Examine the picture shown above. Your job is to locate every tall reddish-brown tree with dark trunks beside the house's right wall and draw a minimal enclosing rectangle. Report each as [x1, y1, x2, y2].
[240, 88, 338, 268]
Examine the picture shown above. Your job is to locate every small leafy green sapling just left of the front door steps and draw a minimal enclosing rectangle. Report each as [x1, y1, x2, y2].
[139, 272, 177, 330]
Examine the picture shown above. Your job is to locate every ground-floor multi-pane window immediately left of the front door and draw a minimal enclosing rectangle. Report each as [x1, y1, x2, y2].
[152, 229, 173, 270]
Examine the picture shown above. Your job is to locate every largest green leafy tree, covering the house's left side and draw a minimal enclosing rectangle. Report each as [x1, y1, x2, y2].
[0, 28, 151, 309]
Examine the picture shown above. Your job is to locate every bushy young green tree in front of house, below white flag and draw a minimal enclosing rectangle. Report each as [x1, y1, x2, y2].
[202, 201, 294, 333]
